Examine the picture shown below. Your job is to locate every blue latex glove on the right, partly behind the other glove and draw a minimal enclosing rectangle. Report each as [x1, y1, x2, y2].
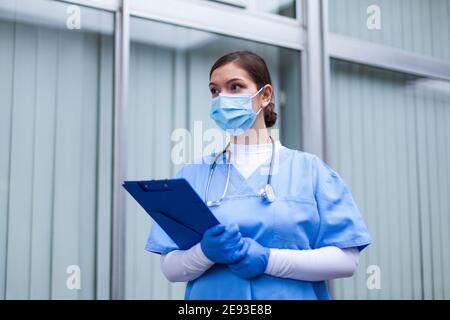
[228, 238, 270, 279]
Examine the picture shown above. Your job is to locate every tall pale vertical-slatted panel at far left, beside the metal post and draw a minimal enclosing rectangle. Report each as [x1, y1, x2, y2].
[0, 21, 113, 299]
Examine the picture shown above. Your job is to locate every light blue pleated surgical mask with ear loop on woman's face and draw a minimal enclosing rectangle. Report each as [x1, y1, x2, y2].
[209, 86, 265, 136]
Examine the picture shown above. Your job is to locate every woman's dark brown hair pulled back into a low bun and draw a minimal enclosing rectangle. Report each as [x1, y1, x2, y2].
[209, 51, 277, 128]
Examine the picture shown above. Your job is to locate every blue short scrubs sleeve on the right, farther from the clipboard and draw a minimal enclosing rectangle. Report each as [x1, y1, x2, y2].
[312, 156, 372, 251]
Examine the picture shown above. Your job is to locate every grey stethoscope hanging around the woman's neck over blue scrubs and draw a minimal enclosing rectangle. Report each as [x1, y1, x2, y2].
[205, 136, 275, 207]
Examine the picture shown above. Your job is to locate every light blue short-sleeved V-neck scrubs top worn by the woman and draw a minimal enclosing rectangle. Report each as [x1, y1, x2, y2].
[145, 148, 371, 300]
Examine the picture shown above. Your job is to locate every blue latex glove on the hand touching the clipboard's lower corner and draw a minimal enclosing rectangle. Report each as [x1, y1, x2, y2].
[200, 224, 248, 264]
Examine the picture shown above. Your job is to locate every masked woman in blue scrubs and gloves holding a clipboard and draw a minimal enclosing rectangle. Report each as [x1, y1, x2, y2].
[146, 51, 371, 299]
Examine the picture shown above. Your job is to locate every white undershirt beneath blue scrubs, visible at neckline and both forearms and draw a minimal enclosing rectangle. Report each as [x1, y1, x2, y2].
[161, 141, 359, 282]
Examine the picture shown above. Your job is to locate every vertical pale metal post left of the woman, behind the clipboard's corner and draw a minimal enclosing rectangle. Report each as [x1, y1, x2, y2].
[111, 0, 129, 299]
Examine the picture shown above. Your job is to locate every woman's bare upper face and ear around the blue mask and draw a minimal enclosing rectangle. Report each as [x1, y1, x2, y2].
[209, 63, 272, 114]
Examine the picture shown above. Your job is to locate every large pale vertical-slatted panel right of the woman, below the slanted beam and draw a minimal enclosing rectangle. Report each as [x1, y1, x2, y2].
[327, 61, 450, 299]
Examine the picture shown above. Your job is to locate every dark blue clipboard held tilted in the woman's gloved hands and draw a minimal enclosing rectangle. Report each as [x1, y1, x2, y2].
[122, 179, 219, 250]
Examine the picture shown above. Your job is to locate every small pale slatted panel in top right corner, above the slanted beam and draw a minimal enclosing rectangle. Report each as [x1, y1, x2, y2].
[329, 0, 450, 60]
